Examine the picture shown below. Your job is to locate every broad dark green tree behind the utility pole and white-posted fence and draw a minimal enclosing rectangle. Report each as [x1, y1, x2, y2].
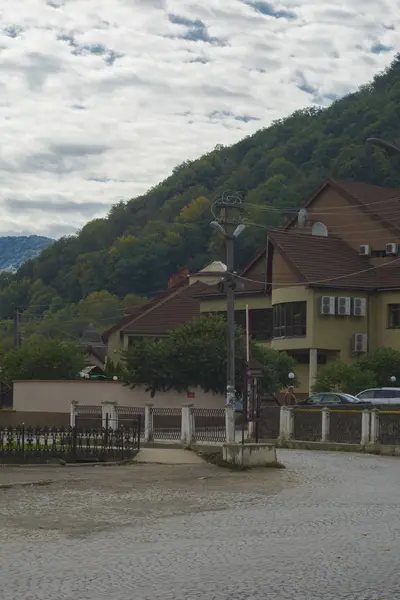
[124, 316, 295, 395]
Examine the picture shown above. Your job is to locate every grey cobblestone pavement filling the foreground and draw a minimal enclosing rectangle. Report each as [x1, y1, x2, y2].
[0, 451, 400, 600]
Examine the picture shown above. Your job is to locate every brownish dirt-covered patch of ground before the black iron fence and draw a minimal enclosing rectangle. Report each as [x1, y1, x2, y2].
[0, 463, 291, 537]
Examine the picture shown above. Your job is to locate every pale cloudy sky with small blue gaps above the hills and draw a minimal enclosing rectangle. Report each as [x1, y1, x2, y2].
[0, 0, 400, 237]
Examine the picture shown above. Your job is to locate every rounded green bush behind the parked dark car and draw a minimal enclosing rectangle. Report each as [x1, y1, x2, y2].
[313, 360, 377, 395]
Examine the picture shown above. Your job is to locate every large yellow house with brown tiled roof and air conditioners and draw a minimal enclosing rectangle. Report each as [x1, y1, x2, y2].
[200, 180, 400, 393]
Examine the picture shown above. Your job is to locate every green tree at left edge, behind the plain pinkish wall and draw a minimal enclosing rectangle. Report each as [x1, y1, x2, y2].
[0, 340, 85, 387]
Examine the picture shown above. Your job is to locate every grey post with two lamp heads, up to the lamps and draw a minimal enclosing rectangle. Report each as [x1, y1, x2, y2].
[210, 218, 245, 405]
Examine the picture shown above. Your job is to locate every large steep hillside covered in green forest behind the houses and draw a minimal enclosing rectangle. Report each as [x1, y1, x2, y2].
[0, 55, 400, 346]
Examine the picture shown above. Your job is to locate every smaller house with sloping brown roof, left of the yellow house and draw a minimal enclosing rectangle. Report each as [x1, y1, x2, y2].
[102, 261, 226, 362]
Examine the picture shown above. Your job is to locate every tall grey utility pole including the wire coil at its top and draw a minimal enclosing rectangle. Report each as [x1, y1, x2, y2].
[211, 194, 245, 405]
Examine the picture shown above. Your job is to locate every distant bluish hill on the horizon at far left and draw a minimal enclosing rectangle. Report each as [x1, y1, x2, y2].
[0, 235, 54, 273]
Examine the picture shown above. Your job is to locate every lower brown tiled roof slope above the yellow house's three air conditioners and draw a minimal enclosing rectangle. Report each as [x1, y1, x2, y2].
[270, 231, 379, 289]
